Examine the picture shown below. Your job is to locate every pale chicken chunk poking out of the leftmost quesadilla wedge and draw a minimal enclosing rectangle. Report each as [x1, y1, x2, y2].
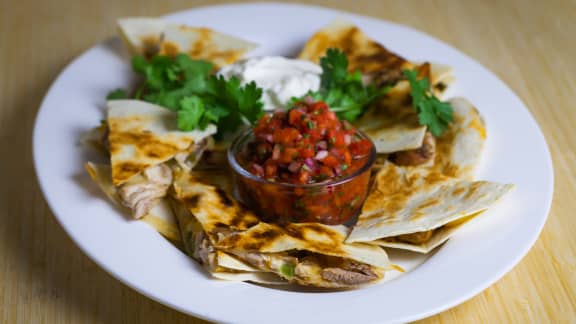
[118, 164, 172, 219]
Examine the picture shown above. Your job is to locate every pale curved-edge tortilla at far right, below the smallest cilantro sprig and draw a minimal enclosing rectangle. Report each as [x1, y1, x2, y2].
[433, 98, 486, 180]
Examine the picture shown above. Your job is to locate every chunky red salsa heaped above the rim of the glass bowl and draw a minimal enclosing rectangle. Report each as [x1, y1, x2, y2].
[246, 101, 372, 184]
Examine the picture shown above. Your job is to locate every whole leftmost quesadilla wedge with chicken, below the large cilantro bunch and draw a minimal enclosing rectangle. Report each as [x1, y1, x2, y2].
[87, 100, 216, 219]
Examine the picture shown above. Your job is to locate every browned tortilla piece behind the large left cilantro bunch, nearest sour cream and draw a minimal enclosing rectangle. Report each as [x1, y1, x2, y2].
[160, 24, 256, 67]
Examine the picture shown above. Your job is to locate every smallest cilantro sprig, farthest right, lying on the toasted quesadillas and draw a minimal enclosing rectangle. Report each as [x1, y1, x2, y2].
[403, 70, 453, 136]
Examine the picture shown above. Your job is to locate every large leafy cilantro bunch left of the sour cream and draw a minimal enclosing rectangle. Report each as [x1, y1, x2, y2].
[107, 54, 263, 136]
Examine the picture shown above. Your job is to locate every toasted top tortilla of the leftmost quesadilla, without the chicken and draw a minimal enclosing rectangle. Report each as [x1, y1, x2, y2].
[107, 100, 216, 186]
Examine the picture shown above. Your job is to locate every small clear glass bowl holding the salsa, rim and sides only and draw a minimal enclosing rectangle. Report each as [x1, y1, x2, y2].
[228, 129, 376, 225]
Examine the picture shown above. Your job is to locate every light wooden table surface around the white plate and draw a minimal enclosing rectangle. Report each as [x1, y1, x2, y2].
[0, 0, 576, 324]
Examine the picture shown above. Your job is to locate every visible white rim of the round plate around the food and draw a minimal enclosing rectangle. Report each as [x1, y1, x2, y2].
[34, 4, 553, 324]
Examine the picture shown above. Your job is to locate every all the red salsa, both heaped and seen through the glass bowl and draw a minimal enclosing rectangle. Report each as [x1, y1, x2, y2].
[236, 102, 374, 224]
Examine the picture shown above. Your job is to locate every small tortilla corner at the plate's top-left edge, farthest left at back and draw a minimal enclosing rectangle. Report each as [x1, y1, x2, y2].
[118, 17, 168, 57]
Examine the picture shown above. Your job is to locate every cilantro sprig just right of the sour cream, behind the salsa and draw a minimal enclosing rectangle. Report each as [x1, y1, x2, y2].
[292, 48, 389, 121]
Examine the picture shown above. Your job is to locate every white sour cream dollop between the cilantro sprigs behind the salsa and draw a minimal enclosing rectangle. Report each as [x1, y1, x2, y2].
[218, 56, 322, 110]
